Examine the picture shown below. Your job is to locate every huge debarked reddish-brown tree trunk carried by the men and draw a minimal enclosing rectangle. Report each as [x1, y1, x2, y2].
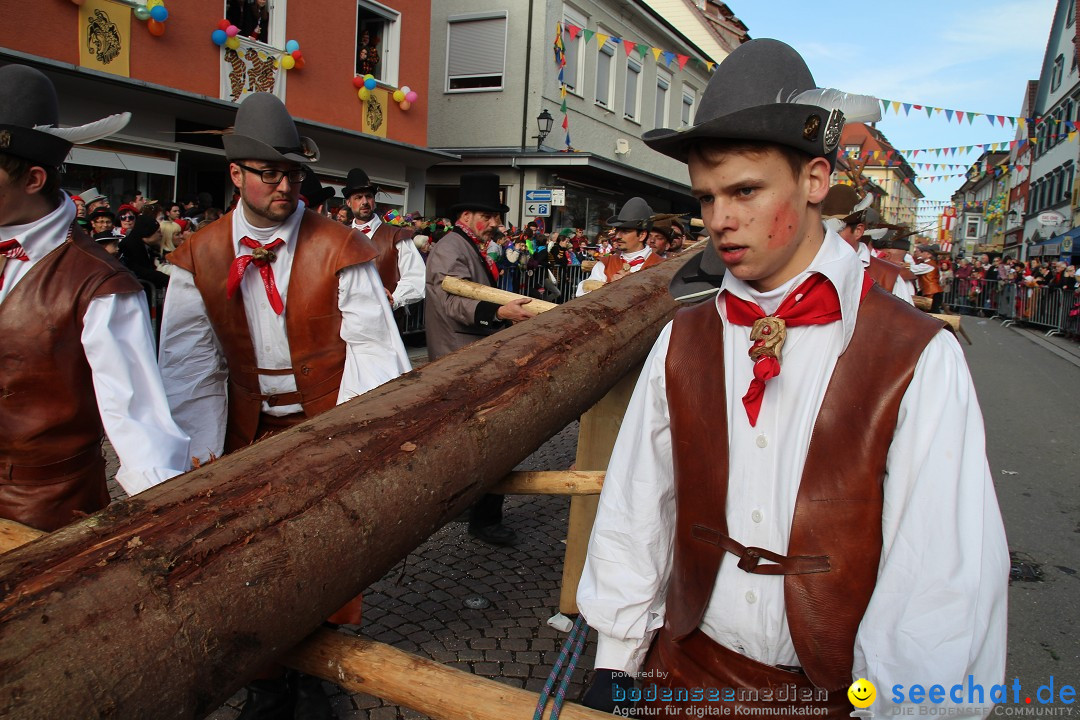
[0, 254, 685, 718]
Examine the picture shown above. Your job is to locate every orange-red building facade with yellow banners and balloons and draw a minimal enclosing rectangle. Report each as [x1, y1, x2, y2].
[0, 0, 454, 208]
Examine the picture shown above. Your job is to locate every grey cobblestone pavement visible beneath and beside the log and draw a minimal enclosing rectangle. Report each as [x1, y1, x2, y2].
[110, 422, 595, 720]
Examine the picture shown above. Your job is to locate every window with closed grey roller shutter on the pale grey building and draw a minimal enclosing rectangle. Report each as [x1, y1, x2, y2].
[446, 11, 507, 93]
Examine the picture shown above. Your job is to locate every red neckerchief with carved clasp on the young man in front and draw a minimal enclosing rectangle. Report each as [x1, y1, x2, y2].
[725, 272, 874, 427]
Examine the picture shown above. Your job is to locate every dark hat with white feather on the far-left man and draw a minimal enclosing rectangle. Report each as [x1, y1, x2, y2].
[0, 65, 131, 167]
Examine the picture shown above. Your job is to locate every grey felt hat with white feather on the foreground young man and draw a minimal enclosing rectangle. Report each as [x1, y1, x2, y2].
[642, 38, 881, 164]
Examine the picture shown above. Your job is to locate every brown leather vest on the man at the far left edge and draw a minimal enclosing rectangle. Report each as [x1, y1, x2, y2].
[0, 226, 143, 531]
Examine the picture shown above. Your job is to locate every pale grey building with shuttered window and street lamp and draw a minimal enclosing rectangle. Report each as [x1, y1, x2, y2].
[423, 0, 728, 234]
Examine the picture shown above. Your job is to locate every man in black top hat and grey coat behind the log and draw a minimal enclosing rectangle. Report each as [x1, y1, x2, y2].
[424, 173, 535, 545]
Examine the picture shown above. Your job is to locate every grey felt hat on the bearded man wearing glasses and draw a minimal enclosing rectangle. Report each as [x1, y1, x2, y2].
[221, 93, 319, 163]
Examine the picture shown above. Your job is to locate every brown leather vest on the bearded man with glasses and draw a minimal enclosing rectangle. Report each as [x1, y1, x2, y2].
[168, 210, 375, 452]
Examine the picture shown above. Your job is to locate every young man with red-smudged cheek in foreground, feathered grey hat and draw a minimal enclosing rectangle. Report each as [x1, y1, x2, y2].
[578, 39, 1009, 718]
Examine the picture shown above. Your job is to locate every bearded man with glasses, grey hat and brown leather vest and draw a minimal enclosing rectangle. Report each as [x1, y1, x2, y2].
[160, 93, 410, 720]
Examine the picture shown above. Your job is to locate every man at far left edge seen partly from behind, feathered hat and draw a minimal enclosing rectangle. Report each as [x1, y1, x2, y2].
[0, 65, 189, 530]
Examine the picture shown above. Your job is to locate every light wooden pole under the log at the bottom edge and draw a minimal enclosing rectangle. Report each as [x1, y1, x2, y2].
[285, 629, 611, 720]
